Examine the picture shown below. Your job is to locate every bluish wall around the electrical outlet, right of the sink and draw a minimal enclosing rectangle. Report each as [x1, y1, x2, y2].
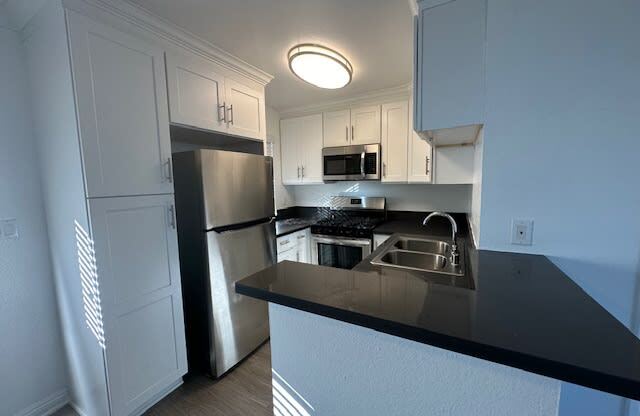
[480, 0, 640, 415]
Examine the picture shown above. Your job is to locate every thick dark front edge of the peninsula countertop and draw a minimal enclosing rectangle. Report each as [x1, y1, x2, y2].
[235, 282, 640, 400]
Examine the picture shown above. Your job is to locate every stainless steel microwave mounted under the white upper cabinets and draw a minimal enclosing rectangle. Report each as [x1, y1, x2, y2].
[322, 144, 380, 182]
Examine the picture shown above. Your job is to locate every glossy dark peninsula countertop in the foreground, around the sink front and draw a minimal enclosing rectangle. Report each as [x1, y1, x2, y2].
[236, 245, 640, 400]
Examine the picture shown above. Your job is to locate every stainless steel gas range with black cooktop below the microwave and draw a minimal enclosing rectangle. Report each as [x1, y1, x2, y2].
[311, 196, 386, 269]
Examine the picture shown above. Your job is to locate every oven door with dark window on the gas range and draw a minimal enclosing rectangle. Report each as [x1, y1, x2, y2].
[311, 235, 371, 269]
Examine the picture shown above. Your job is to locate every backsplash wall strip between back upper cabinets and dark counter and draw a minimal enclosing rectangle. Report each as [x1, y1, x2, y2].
[288, 182, 471, 212]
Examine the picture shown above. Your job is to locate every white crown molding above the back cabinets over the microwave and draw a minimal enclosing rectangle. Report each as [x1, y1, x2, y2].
[278, 84, 411, 118]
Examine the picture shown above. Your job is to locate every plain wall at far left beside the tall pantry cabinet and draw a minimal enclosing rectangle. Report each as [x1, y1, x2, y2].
[0, 6, 67, 415]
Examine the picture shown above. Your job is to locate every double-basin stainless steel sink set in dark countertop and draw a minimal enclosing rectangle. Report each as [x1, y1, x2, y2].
[371, 235, 465, 276]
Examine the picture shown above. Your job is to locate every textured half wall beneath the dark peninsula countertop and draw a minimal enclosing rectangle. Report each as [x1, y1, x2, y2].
[269, 304, 560, 416]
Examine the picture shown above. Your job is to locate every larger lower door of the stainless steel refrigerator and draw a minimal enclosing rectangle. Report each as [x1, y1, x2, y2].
[207, 222, 276, 377]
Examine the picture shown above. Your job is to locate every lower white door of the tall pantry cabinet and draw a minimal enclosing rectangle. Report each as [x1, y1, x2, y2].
[88, 195, 187, 416]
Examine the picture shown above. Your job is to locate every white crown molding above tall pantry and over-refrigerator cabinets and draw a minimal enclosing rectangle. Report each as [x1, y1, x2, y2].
[62, 0, 273, 85]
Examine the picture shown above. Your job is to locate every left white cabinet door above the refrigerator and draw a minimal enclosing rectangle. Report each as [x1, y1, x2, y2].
[166, 53, 227, 132]
